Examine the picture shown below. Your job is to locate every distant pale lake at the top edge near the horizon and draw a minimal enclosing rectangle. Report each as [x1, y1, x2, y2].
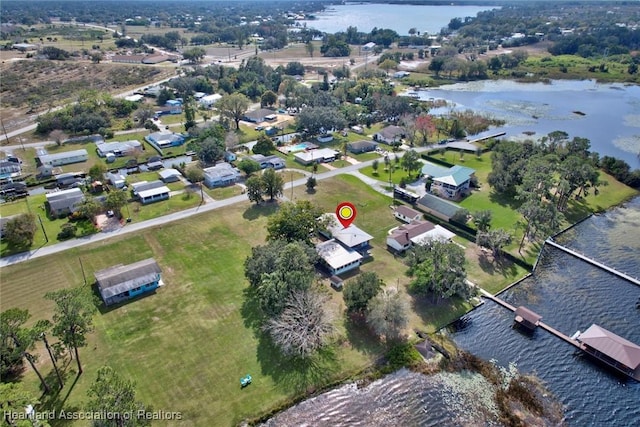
[299, 3, 497, 35]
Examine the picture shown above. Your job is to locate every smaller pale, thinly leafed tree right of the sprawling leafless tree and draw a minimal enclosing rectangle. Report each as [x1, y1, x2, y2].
[367, 288, 409, 341]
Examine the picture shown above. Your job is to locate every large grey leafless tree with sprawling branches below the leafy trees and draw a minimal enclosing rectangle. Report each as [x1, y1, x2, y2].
[265, 289, 335, 357]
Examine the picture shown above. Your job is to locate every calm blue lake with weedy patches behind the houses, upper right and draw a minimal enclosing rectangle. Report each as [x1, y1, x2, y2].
[418, 80, 640, 168]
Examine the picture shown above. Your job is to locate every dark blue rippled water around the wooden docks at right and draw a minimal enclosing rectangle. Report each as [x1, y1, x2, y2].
[452, 198, 640, 426]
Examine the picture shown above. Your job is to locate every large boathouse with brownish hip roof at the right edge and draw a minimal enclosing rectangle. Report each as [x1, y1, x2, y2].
[578, 324, 640, 381]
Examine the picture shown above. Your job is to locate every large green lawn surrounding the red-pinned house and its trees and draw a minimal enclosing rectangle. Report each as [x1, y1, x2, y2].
[1, 176, 504, 425]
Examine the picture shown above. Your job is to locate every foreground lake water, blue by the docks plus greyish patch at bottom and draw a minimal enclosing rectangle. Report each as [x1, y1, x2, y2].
[266, 197, 640, 427]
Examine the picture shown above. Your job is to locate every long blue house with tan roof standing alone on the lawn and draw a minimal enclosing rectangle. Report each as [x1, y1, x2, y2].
[95, 258, 162, 305]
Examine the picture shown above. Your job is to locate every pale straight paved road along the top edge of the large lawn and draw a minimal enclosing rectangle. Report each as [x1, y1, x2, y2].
[0, 147, 436, 267]
